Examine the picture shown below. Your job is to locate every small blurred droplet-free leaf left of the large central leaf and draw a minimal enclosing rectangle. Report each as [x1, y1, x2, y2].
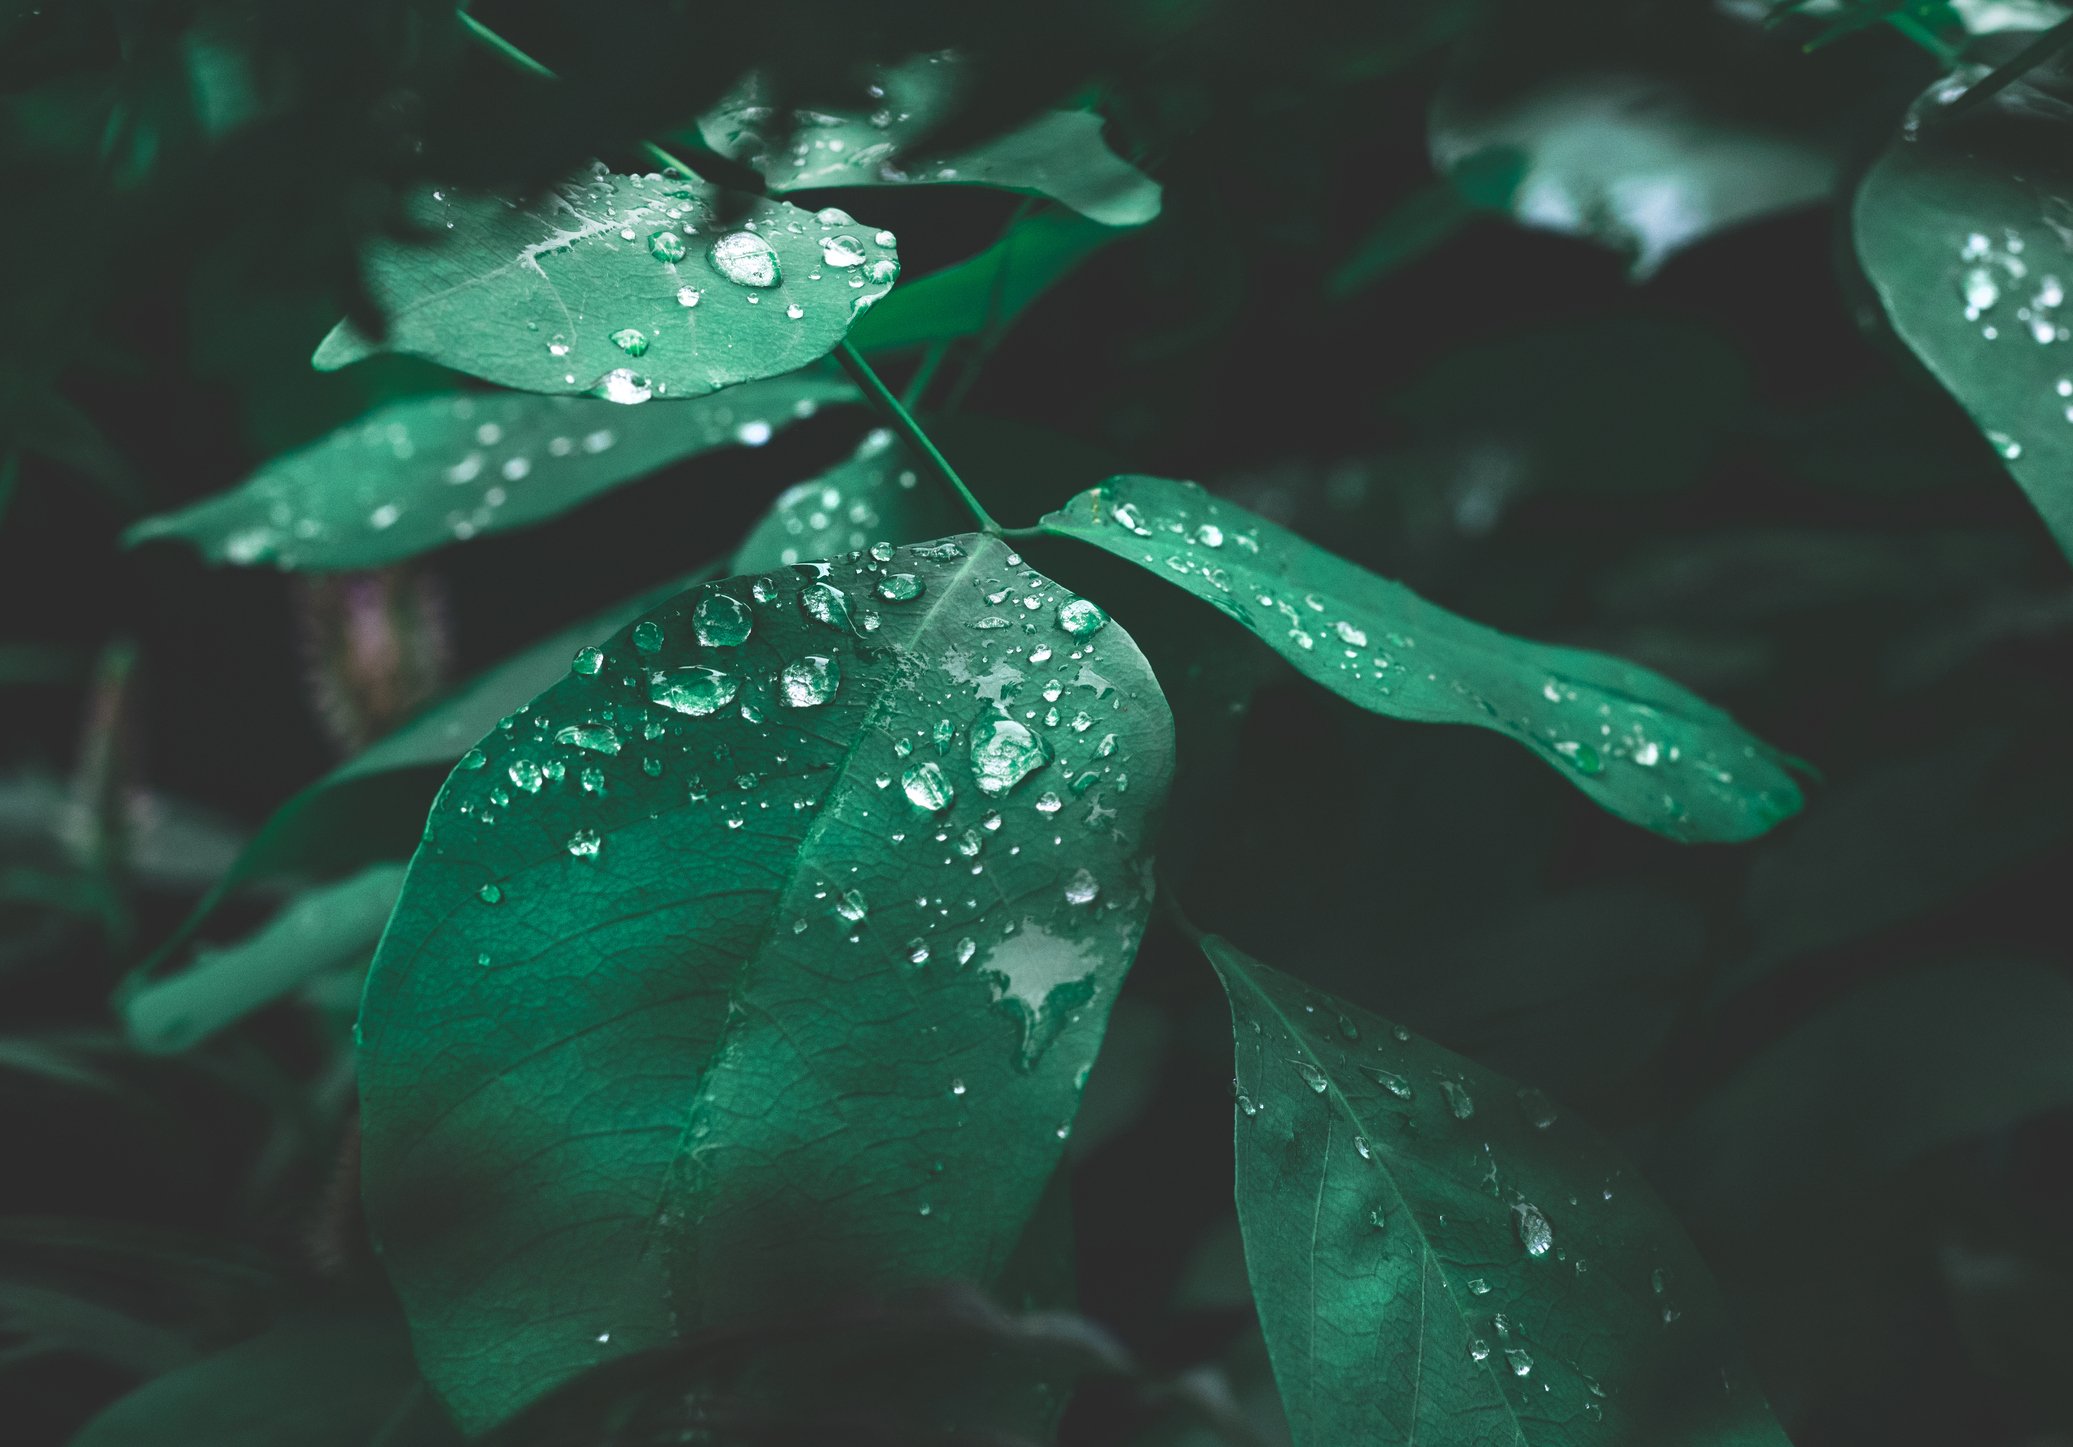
[122, 864, 402, 1053]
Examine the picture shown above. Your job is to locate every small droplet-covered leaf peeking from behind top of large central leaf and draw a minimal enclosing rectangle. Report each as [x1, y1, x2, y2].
[732, 427, 960, 572]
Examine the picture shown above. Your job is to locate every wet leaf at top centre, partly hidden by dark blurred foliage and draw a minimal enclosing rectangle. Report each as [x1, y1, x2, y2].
[699, 52, 1159, 226]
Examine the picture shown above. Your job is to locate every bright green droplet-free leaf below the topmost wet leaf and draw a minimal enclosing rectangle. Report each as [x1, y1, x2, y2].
[852, 211, 1117, 348]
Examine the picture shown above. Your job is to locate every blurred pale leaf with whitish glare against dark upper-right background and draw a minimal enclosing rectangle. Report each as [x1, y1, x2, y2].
[1430, 6, 1843, 280]
